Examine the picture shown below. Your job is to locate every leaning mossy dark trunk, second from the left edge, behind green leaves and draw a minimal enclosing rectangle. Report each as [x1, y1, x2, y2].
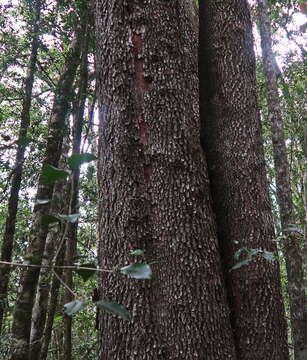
[11, 20, 86, 360]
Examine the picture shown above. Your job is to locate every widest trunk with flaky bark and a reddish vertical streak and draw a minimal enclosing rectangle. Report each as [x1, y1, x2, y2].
[96, 0, 235, 360]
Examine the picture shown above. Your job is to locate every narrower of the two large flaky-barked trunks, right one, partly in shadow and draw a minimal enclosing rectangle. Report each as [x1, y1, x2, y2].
[199, 0, 288, 360]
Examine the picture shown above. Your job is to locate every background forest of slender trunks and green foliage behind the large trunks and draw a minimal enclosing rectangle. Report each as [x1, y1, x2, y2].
[0, 0, 307, 360]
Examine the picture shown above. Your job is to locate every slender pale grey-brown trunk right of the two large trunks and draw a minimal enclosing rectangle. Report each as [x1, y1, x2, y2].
[258, 0, 307, 360]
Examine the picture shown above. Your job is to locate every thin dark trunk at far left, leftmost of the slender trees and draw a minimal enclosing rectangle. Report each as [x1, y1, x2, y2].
[0, 0, 42, 334]
